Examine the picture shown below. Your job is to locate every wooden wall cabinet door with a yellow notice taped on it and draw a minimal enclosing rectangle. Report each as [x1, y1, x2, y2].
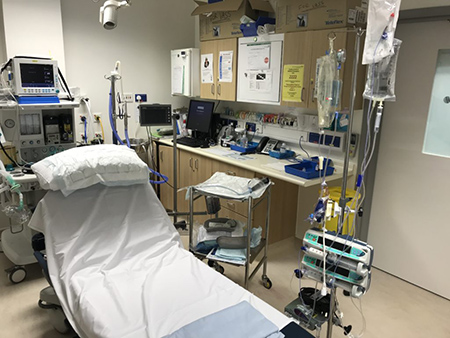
[281, 32, 315, 108]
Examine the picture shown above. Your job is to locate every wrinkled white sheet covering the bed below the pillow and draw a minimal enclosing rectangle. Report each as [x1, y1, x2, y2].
[30, 184, 291, 338]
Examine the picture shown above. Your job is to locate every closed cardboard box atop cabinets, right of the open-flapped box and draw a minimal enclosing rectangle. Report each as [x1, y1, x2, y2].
[276, 0, 368, 33]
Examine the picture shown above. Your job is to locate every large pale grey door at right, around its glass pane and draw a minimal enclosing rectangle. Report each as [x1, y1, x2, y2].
[369, 21, 450, 298]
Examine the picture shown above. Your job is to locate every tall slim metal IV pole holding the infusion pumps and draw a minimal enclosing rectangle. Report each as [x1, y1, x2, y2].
[324, 28, 364, 338]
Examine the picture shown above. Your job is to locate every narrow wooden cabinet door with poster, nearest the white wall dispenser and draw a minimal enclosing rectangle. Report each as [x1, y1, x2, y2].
[200, 41, 217, 100]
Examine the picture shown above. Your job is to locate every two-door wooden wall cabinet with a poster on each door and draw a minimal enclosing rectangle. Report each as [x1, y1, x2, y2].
[200, 38, 237, 101]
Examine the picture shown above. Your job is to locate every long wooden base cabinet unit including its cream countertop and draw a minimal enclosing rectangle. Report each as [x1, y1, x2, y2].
[155, 139, 353, 243]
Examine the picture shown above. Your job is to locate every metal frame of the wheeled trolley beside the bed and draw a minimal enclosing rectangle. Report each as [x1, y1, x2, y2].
[189, 183, 272, 289]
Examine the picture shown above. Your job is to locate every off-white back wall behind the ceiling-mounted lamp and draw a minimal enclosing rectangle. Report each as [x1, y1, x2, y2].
[61, 0, 195, 143]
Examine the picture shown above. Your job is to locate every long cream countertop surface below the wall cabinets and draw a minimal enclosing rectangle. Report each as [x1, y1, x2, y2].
[155, 138, 353, 187]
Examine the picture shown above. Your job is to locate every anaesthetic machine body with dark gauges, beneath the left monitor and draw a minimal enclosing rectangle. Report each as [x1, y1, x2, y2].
[0, 102, 79, 162]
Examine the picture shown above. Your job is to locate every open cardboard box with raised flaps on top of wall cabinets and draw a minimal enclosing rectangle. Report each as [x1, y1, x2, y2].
[191, 0, 274, 41]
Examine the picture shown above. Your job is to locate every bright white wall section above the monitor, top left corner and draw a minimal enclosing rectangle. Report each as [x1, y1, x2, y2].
[3, 0, 65, 73]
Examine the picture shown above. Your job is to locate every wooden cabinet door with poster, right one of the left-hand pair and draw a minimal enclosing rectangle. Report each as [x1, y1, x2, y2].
[214, 39, 237, 101]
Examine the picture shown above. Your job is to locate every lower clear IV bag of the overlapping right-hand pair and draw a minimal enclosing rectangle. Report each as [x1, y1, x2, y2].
[363, 39, 402, 101]
